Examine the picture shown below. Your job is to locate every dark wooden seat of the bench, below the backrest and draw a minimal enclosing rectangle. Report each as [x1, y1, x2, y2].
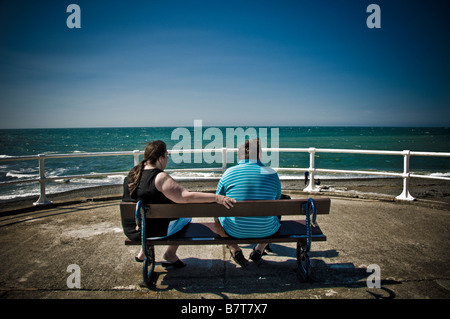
[125, 220, 327, 245]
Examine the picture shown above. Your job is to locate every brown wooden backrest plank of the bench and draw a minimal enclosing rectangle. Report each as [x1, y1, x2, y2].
[120, 198, 330, 219]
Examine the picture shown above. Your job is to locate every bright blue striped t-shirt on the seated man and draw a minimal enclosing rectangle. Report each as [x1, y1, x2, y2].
[216, 160, 281, 238]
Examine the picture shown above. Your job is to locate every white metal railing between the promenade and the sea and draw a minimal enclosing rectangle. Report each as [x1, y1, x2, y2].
[0, 147, 450, 205]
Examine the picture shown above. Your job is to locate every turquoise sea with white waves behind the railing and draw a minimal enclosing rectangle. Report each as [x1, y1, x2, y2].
[0, 126, 450, 200]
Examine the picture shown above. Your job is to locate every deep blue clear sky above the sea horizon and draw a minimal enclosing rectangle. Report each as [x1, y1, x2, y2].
[0, 0, 450, 128]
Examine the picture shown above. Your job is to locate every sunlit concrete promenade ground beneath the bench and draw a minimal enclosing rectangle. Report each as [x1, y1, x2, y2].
[0, 192, 450, 299]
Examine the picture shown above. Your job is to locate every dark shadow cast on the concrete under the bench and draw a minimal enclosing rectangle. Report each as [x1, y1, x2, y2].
[151, 244, 401, 299]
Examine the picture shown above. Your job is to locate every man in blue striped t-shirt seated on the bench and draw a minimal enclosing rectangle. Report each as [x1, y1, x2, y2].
[215, 139, 281, 267]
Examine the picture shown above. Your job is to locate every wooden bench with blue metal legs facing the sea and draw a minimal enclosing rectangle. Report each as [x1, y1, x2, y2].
[120, 198, 330, 287]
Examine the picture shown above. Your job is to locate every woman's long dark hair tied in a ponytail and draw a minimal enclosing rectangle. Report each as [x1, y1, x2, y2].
[127, 140, 167, 196]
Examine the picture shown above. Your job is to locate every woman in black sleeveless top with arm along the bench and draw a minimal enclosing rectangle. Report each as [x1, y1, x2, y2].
[122, 140, 236, 268]
